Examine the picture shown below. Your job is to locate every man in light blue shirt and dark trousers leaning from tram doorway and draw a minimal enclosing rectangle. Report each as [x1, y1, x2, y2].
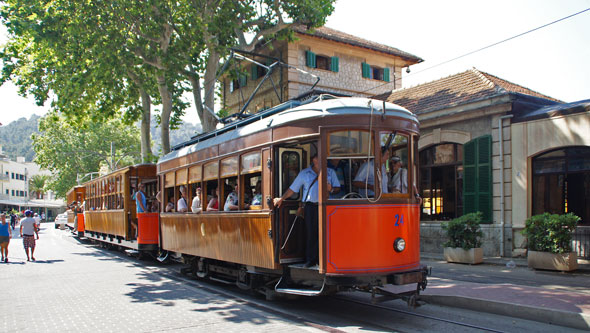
[273, 154, 340, 268]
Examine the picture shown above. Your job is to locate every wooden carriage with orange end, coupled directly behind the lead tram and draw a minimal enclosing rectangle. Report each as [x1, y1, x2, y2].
[83, 164, 158, 251]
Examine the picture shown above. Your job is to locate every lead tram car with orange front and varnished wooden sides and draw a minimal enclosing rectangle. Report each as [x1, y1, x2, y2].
[157, 95, 427, 301]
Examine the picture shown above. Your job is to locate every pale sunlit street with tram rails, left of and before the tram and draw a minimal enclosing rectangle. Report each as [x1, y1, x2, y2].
[0, 223, 588, 332]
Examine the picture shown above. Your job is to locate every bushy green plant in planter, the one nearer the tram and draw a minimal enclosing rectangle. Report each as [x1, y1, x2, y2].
[442, 212, 483, 264]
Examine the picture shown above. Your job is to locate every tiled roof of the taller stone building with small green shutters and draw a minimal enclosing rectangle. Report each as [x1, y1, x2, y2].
[291, 24, 424, 64]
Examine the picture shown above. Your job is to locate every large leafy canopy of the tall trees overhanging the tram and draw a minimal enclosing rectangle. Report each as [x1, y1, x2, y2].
[0, 0, 334, 155]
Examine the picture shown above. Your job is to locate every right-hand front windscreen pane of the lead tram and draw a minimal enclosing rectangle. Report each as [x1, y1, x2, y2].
[379, 130, 413, 198]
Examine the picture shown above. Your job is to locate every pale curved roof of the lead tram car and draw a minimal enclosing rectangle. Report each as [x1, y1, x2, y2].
[158, 97, 418, 163]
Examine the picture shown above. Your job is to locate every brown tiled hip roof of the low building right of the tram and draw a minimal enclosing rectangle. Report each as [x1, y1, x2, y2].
[374, 68, 561, 114]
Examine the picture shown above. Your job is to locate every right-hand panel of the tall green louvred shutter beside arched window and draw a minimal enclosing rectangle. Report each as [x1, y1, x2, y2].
[477, 135, 493, 223]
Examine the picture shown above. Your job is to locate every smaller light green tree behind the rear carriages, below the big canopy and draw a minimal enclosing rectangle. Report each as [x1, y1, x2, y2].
[33, 112, 140, 197]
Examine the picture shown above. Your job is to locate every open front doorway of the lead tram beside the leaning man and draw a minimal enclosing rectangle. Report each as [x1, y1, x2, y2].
[277, 148, 305, 263]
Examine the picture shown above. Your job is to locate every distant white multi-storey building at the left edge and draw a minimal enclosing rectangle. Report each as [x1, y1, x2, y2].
[0, 146, 65, 220]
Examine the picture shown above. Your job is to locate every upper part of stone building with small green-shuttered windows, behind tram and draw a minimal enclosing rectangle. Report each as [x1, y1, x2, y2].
[222, 25, 422, 114]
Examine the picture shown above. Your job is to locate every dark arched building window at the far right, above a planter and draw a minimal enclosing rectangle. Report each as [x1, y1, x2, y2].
[532, 147, 590, 225]
